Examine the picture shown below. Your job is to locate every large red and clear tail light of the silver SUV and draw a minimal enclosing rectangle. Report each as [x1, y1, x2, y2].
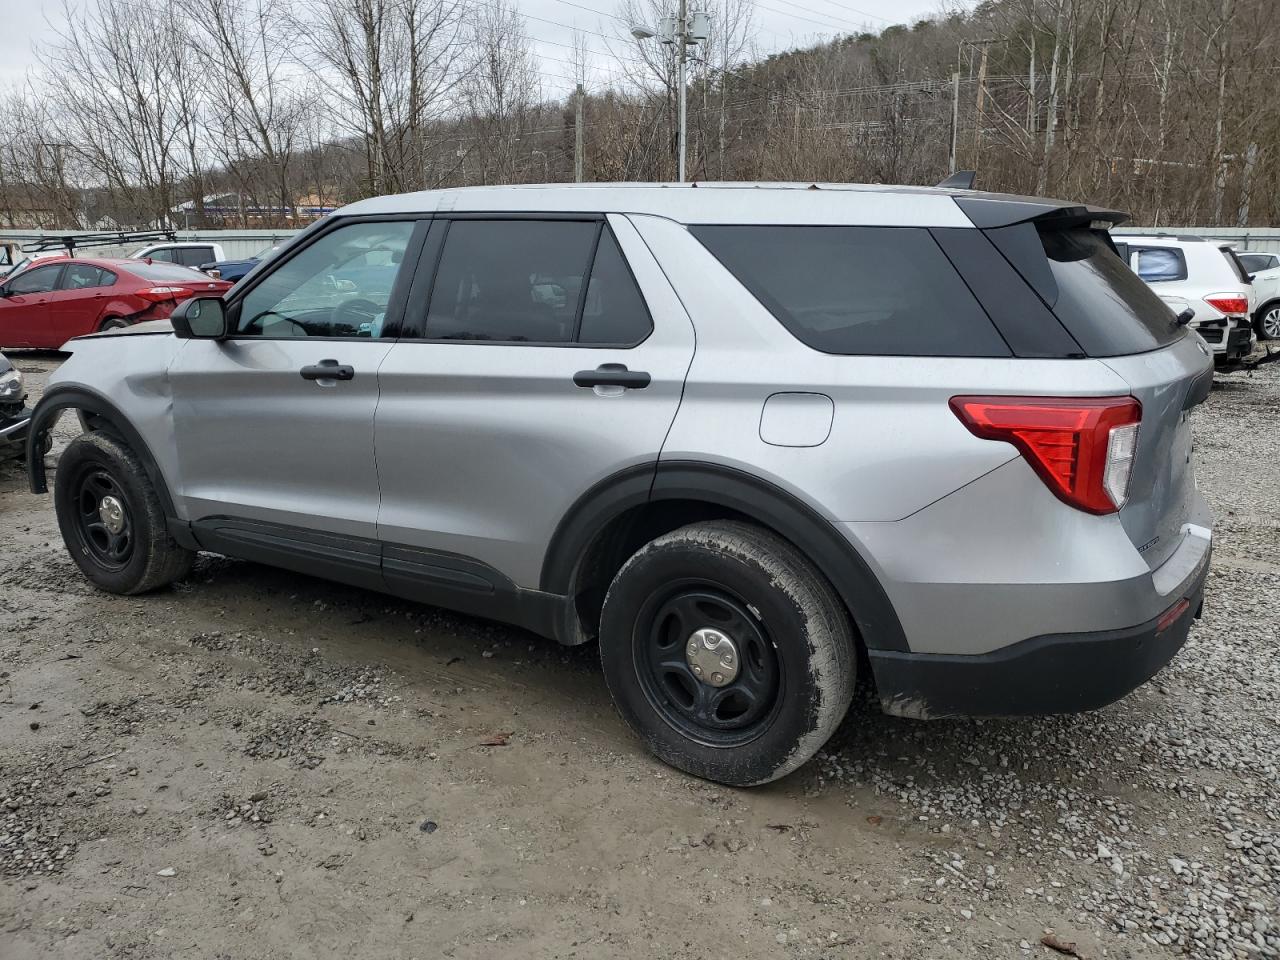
[951, 397, 1142, 513]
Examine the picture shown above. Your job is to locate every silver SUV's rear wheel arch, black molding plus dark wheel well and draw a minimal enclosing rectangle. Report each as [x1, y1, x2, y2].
[541, 461, 910, 652]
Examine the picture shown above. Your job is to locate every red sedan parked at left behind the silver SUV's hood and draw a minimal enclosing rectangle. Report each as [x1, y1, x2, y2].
[0, 257, 232, 349]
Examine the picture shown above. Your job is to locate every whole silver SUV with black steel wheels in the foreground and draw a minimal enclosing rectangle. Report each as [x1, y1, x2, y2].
[29, 184, 1212, 785]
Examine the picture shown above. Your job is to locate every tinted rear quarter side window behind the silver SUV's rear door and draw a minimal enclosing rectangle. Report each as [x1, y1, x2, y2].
[691, 225, 1009, 357]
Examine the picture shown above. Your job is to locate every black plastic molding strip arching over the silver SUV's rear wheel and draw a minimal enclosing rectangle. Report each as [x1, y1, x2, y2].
[539, 460, 910, 652]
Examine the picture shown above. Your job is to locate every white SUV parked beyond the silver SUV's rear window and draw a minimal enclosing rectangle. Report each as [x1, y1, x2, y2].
[1112, 234, 1256, 364]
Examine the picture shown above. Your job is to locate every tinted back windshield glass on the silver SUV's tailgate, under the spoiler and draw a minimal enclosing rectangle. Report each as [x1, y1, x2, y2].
[1028, 227, 1181, 357]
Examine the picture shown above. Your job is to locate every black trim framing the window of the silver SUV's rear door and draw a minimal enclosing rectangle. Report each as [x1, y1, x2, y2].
[397, 211, 655, 349]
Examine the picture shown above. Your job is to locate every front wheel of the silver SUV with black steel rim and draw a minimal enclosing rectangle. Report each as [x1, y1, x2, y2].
[54, 433, 195, 594]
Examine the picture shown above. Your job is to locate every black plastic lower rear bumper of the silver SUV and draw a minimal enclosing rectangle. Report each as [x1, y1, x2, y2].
[869, 573, 1204, 719]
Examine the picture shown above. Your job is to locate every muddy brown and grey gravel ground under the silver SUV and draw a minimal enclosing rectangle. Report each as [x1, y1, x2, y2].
[0, 353, 1280, 960]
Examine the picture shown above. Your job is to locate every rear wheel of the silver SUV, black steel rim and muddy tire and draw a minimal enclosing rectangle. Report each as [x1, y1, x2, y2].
[600, 521, 858, 786]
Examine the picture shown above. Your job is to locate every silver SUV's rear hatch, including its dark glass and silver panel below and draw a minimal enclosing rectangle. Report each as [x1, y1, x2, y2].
[957, 200, 1213, 568]
